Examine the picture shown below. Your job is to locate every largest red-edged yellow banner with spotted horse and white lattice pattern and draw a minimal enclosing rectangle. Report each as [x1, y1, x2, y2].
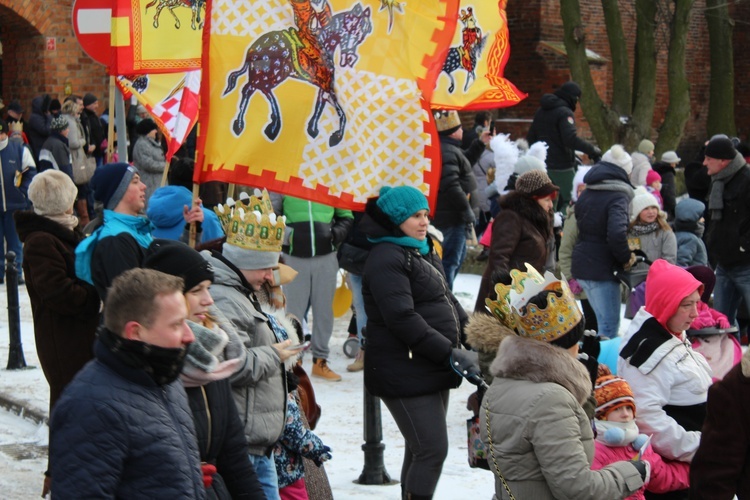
[195, 0, 459, 209]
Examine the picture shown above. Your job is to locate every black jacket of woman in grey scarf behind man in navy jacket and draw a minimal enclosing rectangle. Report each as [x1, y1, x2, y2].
[185, 379, 266, 500]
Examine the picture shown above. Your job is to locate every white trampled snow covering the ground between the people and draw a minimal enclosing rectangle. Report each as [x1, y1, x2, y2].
[0, 274, 494, 500]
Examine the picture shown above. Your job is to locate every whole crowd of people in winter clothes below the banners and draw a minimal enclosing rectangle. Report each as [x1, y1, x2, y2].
[0, 82, 750, 500]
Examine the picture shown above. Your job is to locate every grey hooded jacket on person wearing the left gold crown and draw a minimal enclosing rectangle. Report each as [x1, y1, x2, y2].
[201, 251, 292, 455]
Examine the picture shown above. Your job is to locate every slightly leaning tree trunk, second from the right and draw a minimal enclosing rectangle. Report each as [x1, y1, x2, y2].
[655, 0, 694, 155]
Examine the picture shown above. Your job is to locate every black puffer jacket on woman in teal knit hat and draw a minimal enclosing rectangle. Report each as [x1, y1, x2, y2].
[361, 201, 468, 398]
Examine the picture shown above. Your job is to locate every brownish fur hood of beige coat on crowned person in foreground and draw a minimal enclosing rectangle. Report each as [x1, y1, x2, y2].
[490, 336, 591, 405]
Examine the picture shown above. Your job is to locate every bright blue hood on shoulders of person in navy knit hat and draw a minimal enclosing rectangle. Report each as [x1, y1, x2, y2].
[76, 209, 154, 285]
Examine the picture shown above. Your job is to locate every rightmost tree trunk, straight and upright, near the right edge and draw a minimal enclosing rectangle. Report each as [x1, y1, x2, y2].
[705, 0, 737, 137]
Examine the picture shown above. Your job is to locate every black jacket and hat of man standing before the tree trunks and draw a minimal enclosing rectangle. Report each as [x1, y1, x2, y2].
[526, 94, 597, 170]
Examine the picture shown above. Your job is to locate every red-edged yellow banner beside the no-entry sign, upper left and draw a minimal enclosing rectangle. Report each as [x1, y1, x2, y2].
[109, 0, 207, 76]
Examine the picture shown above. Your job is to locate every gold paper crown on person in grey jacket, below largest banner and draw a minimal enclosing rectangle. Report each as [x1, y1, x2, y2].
[214, 189, 286, 252]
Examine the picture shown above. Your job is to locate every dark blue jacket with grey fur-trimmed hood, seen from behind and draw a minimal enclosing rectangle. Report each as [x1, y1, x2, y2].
[571, 162, 633, 281]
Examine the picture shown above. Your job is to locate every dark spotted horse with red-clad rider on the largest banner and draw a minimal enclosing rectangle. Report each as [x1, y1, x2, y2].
[222, 0, 372, 147]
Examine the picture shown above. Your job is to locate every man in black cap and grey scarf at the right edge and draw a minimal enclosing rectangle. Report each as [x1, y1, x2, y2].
[703, 137, 750, 330]
